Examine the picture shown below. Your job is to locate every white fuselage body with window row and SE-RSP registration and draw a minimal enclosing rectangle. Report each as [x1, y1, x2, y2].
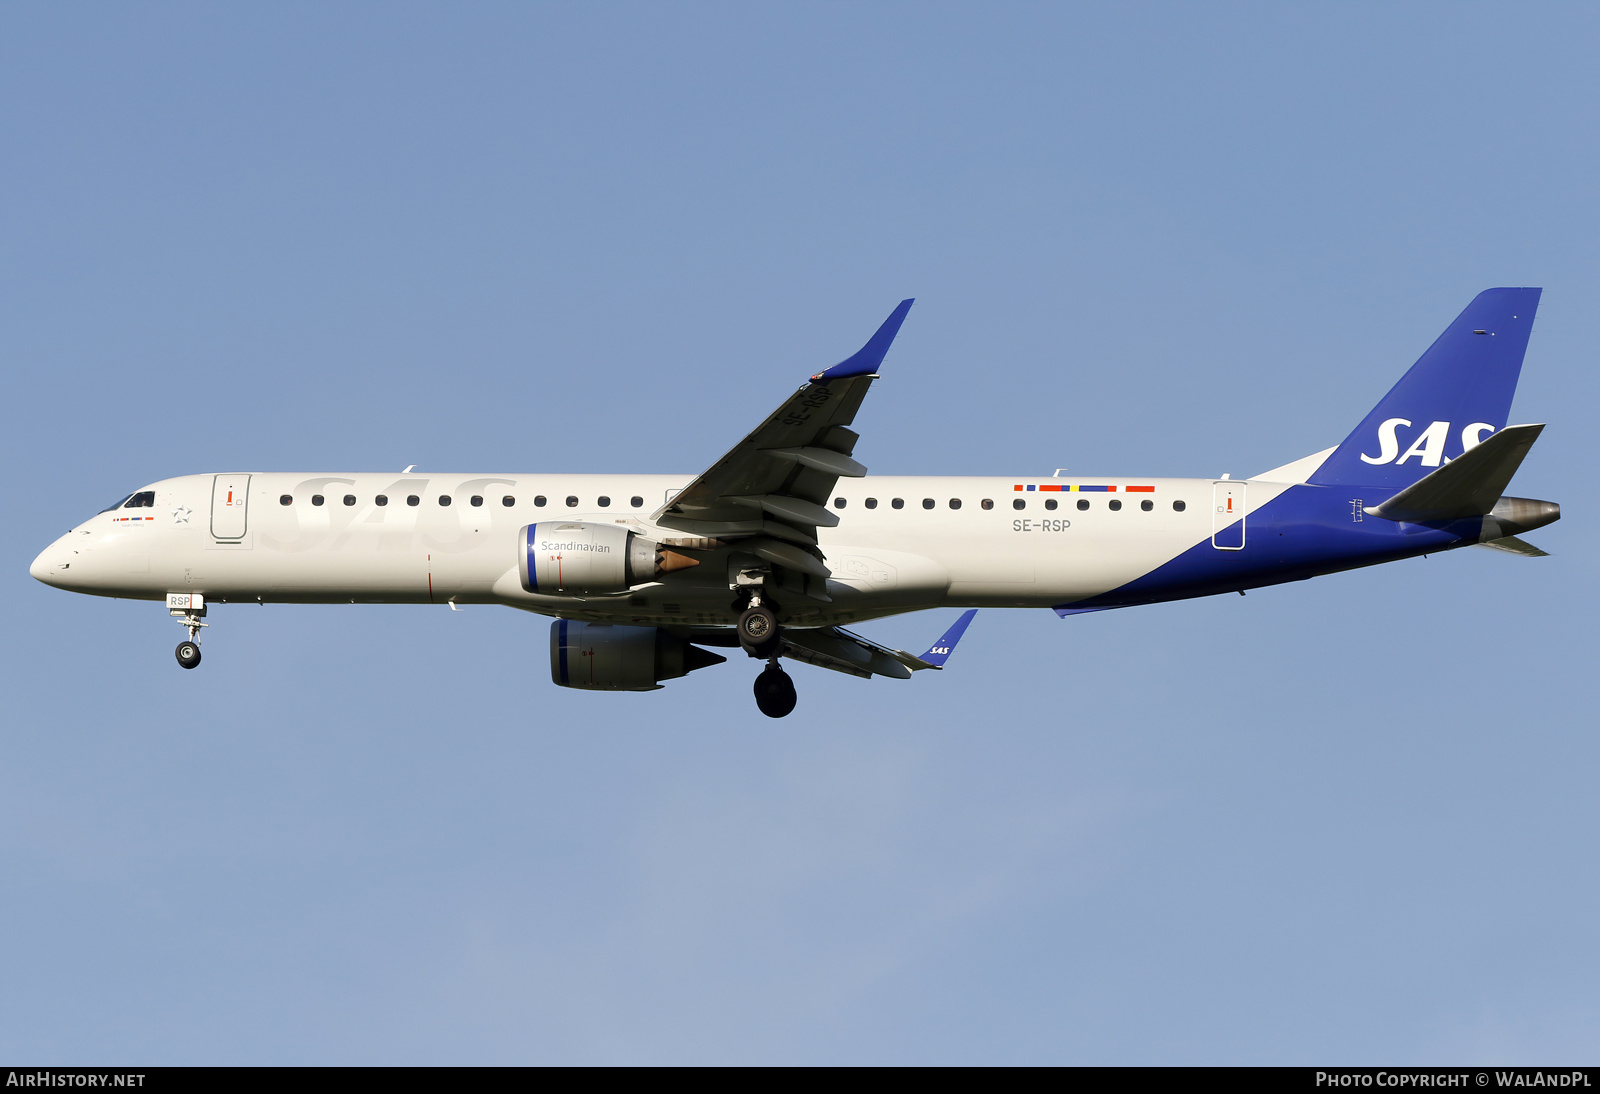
[32, 473, 1286, 627]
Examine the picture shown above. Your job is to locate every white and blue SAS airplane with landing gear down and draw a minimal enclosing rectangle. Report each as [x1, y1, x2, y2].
[30, 288, 1560, 718]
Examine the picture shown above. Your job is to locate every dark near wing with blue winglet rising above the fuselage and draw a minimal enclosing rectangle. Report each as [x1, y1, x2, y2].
[651, 301, 912, 600]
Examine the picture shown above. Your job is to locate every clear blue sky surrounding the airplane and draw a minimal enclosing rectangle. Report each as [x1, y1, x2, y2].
[0, 3, 1600, 1064]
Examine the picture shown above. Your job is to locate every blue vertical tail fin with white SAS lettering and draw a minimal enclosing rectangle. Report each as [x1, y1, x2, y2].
[1307, 288, 1541, 491]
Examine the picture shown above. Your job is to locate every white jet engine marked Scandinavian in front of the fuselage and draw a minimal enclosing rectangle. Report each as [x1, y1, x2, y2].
[518, 520, 699, 597]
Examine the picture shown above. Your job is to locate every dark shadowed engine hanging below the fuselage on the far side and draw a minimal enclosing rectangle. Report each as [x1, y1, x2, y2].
[550, 619, 726, 691]
